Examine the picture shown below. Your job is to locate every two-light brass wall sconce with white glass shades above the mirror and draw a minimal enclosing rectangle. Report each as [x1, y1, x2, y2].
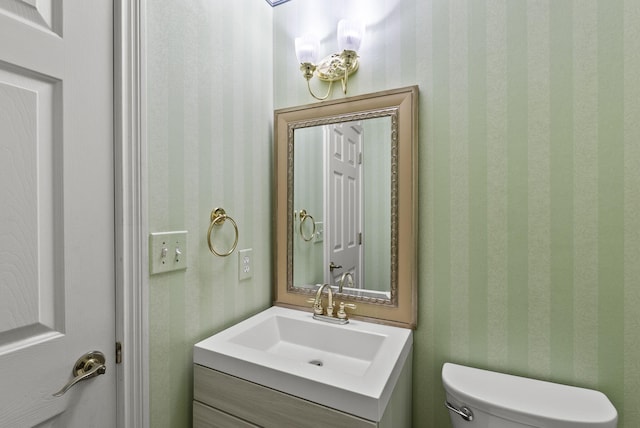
[295, 19, 364, 101]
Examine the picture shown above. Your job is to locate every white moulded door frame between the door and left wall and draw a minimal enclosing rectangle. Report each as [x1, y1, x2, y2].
[113, 0, 149, 428]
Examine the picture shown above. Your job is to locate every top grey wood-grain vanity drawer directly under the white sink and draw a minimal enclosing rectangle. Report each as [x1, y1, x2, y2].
[194, 364, 378, 428]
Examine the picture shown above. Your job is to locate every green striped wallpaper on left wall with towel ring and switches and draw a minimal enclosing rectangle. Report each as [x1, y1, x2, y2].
[146, 0, 273, 428]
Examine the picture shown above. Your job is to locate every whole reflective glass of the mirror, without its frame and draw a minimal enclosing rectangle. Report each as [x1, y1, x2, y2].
[292, 116, 392, 301]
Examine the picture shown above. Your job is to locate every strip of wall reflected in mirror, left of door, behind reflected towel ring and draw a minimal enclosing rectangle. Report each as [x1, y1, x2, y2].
[293, 127, 324, 285]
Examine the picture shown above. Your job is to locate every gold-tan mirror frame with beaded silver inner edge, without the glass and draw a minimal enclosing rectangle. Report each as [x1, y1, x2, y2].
[274, 86, 419, 328]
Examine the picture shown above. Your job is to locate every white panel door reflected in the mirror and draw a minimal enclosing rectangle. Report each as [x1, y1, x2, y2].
[324, 122, 363, 287]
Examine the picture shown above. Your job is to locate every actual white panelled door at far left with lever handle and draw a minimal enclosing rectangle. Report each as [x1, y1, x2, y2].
[0, 0, 116, 428]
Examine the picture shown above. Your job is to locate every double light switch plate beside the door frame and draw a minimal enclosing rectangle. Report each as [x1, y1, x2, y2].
[149, 230, 187, 275]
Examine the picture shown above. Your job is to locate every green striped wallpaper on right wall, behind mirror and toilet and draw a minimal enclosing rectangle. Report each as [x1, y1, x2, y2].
[274, 0, 640, 428]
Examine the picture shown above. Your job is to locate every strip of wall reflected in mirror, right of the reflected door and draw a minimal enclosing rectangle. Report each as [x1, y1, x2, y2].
[362, 117, 391, 291]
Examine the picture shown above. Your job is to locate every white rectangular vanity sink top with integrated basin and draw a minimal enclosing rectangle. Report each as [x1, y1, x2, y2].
[193, 306, 413, 421]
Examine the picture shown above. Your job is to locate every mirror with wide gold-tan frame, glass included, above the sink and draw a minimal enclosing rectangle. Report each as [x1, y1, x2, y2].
[274, 86, 418, 328]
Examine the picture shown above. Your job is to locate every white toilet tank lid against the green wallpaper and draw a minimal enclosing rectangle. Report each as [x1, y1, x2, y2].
[442, 363, 618, 428]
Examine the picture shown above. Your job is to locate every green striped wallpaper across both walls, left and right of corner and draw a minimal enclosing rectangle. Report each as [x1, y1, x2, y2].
[147, 0, 640, 428]
